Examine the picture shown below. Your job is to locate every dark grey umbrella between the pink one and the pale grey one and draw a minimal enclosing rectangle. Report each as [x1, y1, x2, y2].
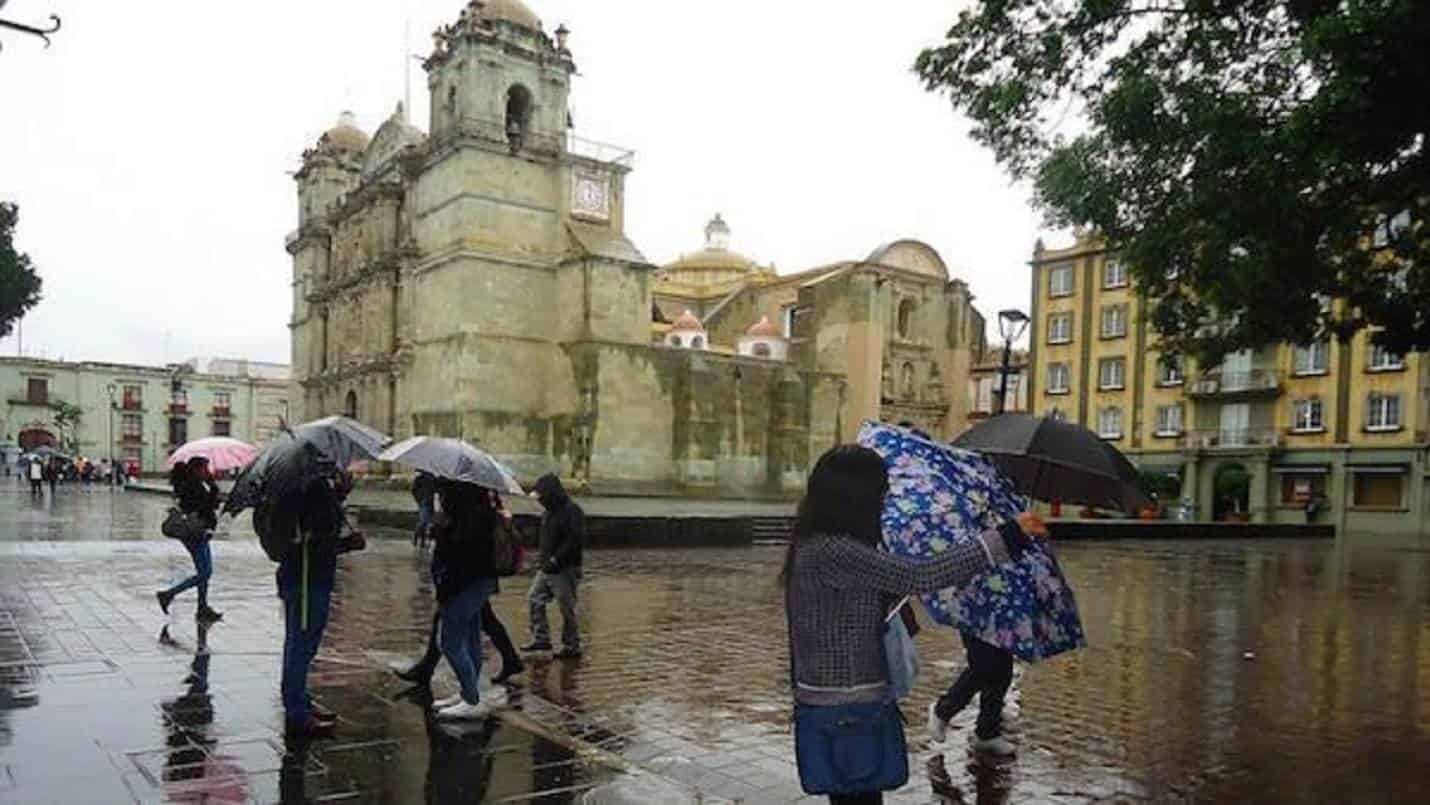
[223, 416, 390, 513]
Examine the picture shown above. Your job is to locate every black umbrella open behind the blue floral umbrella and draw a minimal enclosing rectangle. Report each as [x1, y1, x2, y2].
[954, 413, 1147, 512]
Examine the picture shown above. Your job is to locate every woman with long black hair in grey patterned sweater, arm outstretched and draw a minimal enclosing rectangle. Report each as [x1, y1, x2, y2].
[779, 445, 1047, 805]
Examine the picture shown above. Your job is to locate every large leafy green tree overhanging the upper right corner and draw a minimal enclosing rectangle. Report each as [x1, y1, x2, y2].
[915, 0, 1430, 363]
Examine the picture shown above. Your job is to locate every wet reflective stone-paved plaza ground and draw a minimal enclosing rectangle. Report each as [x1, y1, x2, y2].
[0, 488, 1430, 804]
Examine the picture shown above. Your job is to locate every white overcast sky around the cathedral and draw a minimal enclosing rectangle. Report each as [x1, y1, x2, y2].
[0, 0, 1051, 363]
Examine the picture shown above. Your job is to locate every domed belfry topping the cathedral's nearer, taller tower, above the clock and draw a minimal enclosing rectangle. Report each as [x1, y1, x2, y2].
[423, 0, 576, 159]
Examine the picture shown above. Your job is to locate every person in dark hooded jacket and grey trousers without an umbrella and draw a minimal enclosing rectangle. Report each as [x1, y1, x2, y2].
[523, 475, 586, 659]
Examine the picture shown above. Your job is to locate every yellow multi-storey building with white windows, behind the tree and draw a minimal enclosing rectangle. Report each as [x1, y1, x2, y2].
[1028, 234, 1430, 539]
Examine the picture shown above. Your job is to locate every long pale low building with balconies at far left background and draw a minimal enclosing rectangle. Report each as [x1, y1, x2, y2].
[0, 357, 289, 472]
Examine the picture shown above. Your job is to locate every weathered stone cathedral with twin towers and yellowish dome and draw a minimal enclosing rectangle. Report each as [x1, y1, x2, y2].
[287, 0, 984, 498]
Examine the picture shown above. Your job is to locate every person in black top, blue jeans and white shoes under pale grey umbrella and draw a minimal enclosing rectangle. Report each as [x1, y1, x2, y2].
[432, 482, 506, 719]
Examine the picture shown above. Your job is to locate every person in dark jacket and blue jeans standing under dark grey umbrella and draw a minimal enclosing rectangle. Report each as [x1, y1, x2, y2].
[276, 472, 352, 738]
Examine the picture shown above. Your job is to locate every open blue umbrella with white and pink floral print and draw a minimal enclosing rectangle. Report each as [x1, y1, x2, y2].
[859, 422, 1087, 662]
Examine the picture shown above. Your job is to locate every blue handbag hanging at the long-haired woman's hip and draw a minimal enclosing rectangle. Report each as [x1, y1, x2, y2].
[795, 702, 908, 795]
